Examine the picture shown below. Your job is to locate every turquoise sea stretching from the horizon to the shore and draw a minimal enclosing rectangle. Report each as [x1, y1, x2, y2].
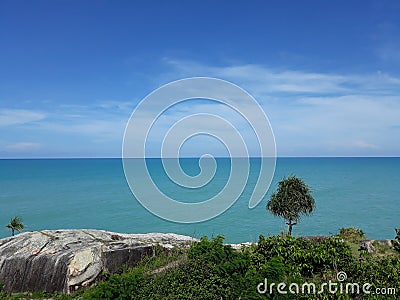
[0, 158, 400, 243]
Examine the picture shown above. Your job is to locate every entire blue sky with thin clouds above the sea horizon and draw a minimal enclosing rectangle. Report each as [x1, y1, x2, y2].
[0, 0, 400, 158]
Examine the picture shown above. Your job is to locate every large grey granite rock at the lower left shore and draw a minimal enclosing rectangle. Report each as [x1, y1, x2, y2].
[0, 230, 195, 293]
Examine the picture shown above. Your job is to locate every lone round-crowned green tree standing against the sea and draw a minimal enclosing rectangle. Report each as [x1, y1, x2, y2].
[267, 175, 315, 235]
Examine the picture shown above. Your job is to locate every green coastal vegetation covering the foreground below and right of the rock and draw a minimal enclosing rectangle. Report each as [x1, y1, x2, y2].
[0, 228, 400, 300]
